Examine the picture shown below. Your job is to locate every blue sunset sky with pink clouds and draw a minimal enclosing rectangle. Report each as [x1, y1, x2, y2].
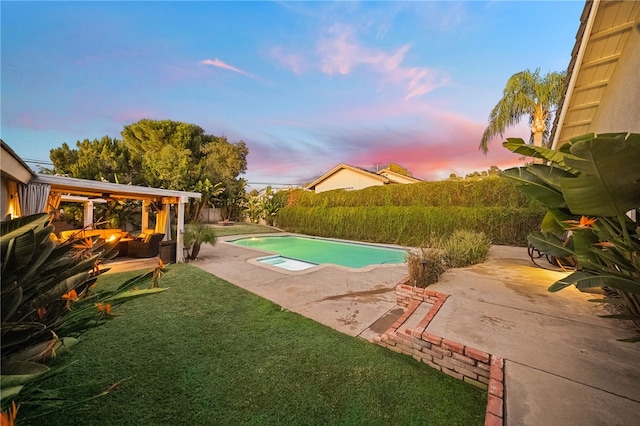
[0, 1, 584, 188]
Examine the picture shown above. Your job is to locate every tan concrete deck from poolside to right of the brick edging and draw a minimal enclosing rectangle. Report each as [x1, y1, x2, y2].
[105, 236, 640, 425]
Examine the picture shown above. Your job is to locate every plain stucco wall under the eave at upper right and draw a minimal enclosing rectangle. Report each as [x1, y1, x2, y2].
[589, 28, 640, 133]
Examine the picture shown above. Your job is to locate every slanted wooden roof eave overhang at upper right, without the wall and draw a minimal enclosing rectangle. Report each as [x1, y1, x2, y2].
[551, 0, 640, 149]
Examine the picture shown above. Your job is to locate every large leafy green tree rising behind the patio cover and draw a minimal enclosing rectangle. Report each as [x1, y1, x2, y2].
[50, 119, 249, 221]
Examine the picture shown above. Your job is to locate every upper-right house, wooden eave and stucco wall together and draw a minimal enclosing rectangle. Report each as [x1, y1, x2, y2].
[551, 0, 640, 149]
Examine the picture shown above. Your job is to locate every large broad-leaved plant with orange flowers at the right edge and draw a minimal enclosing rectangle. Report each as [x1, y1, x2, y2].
[503, 133, 640, 340]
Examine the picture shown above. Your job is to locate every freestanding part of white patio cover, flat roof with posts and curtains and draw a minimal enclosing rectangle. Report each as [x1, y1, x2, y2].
[29, 174, 202, 262]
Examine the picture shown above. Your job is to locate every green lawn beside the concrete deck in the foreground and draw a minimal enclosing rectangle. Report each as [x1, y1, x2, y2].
[30, 264, 486, 425]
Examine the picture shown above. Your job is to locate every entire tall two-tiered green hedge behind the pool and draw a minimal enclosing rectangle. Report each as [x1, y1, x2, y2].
[276, 178, 545, 247]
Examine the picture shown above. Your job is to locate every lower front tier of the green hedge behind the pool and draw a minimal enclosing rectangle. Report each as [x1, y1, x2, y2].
[276, 206, 544, 247]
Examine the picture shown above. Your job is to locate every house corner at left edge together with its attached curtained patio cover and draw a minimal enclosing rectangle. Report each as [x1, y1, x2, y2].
[0, 140, 202, 262]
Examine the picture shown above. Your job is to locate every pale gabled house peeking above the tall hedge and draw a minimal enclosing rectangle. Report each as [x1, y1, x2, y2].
[305, 163, 421, 193]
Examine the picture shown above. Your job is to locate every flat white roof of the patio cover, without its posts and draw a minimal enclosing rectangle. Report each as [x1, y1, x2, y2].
[31, 174, 202, 202]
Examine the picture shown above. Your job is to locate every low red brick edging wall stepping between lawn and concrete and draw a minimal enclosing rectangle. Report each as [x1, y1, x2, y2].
[372, 278, 505, 426]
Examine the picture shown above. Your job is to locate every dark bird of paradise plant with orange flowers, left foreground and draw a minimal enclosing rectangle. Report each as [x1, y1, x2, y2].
[0, 214, 169, 420]
